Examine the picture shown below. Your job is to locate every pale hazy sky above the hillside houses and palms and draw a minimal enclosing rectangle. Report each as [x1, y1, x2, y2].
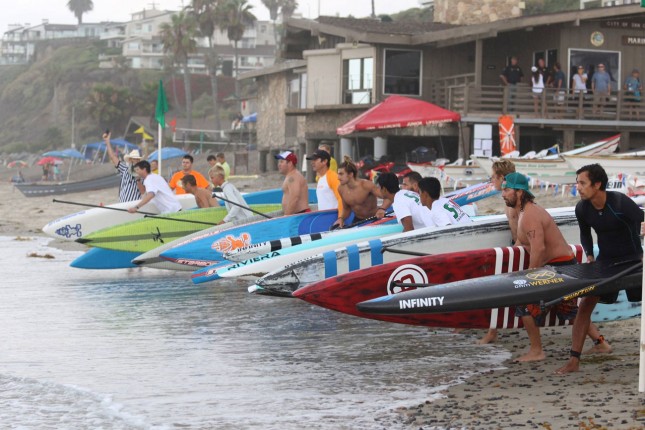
[0, 0, 426, 33]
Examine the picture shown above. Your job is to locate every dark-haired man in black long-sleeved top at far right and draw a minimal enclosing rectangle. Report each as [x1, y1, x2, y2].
[555, 164, 643, 374]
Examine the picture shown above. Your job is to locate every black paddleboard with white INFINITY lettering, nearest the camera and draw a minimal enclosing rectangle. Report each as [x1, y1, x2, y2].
[357, 256, 643, 315]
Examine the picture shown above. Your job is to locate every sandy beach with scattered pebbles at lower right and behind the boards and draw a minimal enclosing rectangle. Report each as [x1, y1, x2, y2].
[0, 173, 645, 429]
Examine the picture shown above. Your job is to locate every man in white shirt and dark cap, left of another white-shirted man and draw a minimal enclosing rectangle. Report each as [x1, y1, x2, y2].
[376, 173, 427, 231]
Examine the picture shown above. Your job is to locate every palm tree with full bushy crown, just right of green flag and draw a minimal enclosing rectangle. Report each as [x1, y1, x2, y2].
[159, 10, 197, 128]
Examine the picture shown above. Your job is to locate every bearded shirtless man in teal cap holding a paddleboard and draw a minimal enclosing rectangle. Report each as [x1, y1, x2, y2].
[502, 172, 600, 362]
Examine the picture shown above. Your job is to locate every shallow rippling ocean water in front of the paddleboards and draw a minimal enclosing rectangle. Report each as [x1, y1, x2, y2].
[0, 237, 509, 430]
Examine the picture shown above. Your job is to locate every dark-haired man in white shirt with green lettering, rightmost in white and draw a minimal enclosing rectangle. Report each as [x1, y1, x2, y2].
[419, 177, 471, 227]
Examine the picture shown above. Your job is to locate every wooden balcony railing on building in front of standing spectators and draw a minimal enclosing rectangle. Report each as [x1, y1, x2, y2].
[448, 84, 645, 126]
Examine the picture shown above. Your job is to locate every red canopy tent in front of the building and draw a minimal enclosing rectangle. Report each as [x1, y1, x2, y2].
[336, 96, 461, 136]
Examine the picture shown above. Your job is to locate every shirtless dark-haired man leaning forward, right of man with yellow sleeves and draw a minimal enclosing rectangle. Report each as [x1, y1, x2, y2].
[332, 156, 392, 229]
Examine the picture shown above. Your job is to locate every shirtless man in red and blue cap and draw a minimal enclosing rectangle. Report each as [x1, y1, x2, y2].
[275, 151, 311, 215]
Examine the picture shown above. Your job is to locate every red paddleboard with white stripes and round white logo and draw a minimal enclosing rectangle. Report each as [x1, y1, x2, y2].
[293, 245, 592, 328]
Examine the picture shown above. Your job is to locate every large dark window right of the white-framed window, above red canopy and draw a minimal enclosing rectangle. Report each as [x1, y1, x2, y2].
[383, 49, 421, 95]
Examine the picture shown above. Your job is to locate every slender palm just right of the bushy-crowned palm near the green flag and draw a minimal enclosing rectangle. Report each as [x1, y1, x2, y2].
[188, 0, 222, 130]
